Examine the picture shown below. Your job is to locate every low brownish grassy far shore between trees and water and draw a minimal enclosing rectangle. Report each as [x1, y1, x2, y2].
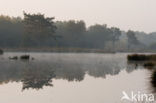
[2, 47, 156, 53]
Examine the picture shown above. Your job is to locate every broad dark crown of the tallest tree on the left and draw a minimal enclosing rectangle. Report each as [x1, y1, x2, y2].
[23, 12, 56, 44]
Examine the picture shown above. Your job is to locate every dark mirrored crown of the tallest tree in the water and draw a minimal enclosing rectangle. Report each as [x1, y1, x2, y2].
[21, 68, 55, 90]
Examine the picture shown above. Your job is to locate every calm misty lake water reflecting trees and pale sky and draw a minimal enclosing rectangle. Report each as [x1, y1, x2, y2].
[0, 53, 153, 103]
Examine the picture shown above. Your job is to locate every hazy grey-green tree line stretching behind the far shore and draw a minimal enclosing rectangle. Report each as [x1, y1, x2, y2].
[0, 12, 156, 52]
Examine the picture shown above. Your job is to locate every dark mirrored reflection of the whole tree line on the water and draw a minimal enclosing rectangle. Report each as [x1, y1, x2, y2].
[0, 54, 141, 90]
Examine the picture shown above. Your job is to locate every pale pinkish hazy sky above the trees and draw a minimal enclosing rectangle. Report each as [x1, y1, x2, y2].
[0, 0, 156, 33]
